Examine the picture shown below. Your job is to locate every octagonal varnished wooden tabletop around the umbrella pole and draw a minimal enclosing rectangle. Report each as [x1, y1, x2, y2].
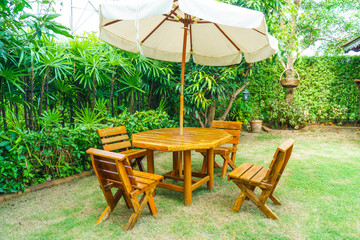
[132, 127, 233, 152]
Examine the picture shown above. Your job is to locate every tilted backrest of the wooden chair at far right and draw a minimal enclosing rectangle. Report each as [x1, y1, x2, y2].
[264, 139, 296, 188]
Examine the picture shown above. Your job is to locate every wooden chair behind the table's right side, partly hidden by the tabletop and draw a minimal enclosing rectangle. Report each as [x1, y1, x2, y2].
[196, 121, 243, 177]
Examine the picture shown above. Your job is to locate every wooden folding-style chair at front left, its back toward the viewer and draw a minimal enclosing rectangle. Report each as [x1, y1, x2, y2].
[86, 148, 164, 231]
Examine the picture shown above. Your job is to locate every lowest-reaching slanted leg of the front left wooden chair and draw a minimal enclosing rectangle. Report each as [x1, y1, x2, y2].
[124, 184, 156, 231]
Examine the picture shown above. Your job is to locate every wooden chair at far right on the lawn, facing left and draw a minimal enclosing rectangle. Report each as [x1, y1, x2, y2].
[228, 139, 295, 220]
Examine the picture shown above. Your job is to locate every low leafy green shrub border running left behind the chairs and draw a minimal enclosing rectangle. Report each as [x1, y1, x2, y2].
[0, 110, 177, 193]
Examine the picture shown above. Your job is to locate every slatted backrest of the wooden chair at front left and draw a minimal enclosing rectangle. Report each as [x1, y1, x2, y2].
[86, 148, 137, 194]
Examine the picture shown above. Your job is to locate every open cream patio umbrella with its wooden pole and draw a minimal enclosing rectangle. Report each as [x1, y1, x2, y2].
[99, 0, 277, 135]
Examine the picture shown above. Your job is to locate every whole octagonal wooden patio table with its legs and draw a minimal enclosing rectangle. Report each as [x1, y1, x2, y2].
[132, 127, 233, 205]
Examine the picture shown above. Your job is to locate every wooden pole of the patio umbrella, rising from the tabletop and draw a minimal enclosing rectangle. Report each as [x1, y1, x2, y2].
[180, 14, 189, 135]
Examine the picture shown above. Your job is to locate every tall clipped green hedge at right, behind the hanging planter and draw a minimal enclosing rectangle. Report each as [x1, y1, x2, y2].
[243, 56, 360, 124]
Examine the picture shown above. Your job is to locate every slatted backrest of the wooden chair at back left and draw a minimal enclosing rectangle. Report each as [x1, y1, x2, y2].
[97, 126, 131, 151]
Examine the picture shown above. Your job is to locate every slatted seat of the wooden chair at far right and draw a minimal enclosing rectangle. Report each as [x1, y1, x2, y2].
[228, 163, 270, 185]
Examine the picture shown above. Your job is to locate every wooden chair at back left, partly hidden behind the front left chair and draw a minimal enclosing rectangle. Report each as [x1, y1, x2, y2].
[97, 126, 146, 172]
